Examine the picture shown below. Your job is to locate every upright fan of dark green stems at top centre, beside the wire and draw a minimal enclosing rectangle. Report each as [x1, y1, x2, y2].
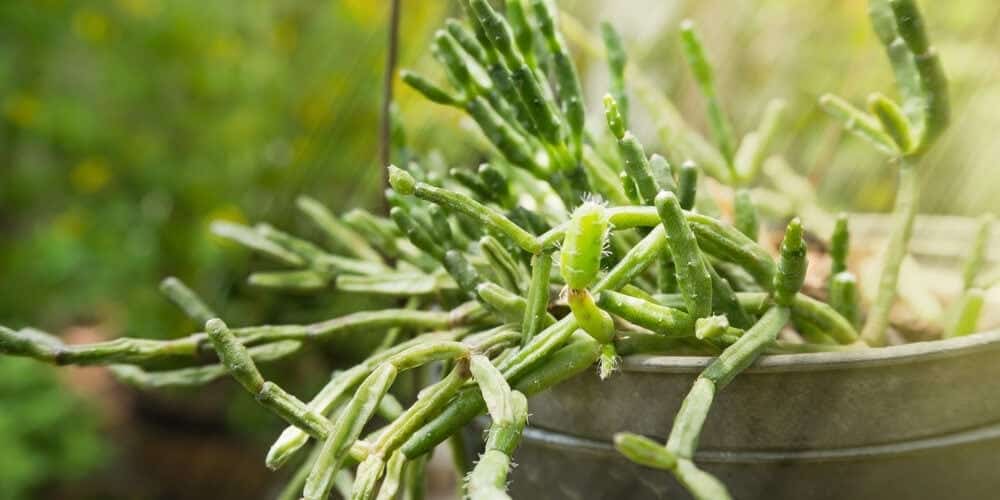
[402, 0, 590, 207]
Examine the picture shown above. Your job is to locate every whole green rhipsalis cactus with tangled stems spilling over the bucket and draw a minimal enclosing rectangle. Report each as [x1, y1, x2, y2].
[0, 0, 996, 499]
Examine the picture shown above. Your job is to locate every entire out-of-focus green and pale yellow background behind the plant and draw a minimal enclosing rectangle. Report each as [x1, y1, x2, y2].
[0, 0, 1000, 500]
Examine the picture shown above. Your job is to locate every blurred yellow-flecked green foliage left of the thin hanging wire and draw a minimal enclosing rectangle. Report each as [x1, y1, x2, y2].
[0, 0, 441, 337]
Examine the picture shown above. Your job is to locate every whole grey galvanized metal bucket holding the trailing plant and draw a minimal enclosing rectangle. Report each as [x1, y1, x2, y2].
[511, 217, 1000, 500]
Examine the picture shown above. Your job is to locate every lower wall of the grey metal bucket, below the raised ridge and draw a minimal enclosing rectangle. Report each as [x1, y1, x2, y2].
[510, 426, 1000, 500]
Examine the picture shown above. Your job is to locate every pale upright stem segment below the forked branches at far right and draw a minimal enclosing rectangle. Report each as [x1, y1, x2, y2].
[861, 160, 919, 346]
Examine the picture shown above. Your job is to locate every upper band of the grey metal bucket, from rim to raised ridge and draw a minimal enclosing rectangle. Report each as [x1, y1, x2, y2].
[529, 331, 1000, 450]
